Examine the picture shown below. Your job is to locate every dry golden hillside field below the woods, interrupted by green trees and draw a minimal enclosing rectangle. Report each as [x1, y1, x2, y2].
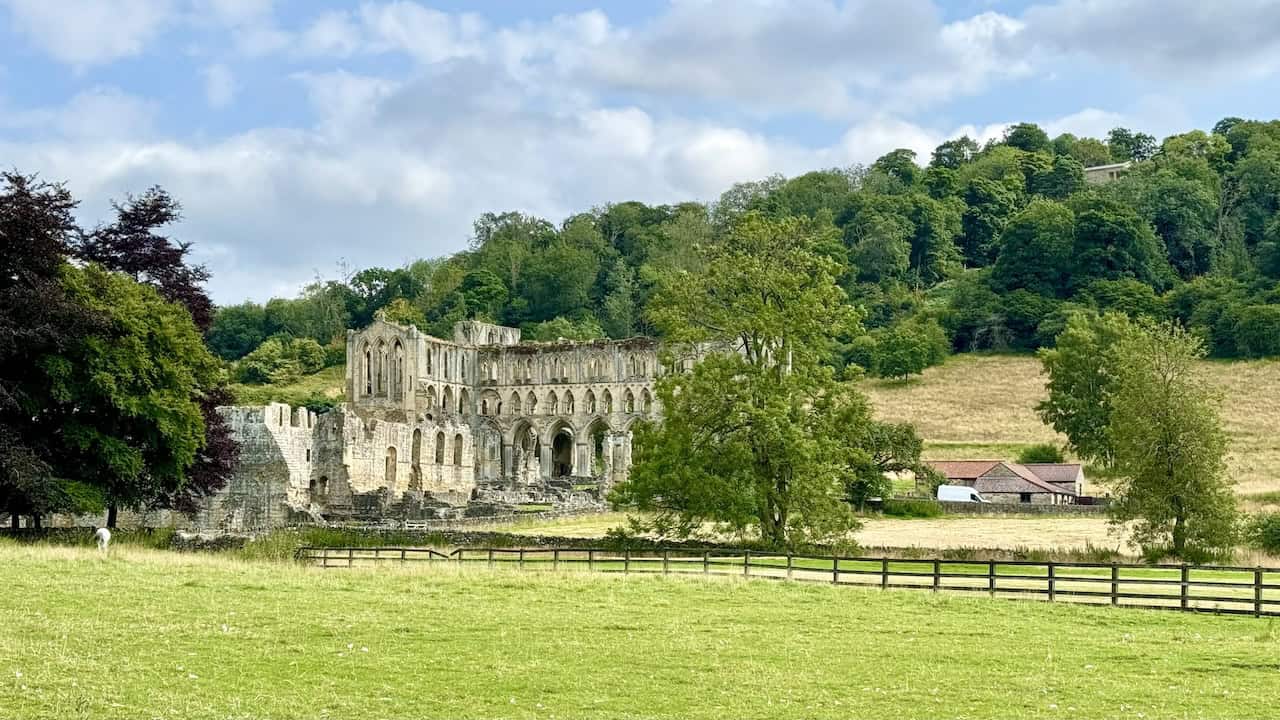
[864, 354, 1280, 503]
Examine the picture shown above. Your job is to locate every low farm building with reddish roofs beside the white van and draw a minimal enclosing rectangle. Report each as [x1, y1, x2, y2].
[929, 460, 1084, 505]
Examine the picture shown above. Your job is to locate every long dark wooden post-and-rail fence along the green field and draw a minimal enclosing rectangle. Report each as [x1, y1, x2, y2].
[297, 547, 1280, 618]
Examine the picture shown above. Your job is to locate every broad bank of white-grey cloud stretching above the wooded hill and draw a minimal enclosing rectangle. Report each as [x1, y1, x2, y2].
[0, 0, 1269, 302]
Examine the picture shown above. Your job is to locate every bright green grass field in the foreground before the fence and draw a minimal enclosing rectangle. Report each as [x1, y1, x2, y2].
[0, 544, 1280, 719]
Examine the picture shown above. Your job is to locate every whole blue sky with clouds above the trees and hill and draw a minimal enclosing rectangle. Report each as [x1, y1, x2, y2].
[0, 0, 1280, 304]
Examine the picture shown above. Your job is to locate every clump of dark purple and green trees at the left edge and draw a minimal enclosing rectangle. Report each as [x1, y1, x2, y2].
[0, 172, 238, 527]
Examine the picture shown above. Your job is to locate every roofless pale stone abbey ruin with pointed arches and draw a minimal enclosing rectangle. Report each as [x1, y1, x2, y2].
[196, 319, 660, 532]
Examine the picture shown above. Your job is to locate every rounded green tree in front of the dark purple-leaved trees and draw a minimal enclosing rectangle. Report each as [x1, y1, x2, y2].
[37, 265, 221, 520]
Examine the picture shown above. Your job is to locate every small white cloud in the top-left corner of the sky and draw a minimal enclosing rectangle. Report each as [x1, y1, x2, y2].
[4, 0, 173, 68]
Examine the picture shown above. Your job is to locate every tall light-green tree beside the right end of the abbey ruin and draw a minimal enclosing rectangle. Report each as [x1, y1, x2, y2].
[614, 214, 906, 546]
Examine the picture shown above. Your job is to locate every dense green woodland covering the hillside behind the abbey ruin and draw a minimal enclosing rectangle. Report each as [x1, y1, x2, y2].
[209, 118, 1280, 382]
